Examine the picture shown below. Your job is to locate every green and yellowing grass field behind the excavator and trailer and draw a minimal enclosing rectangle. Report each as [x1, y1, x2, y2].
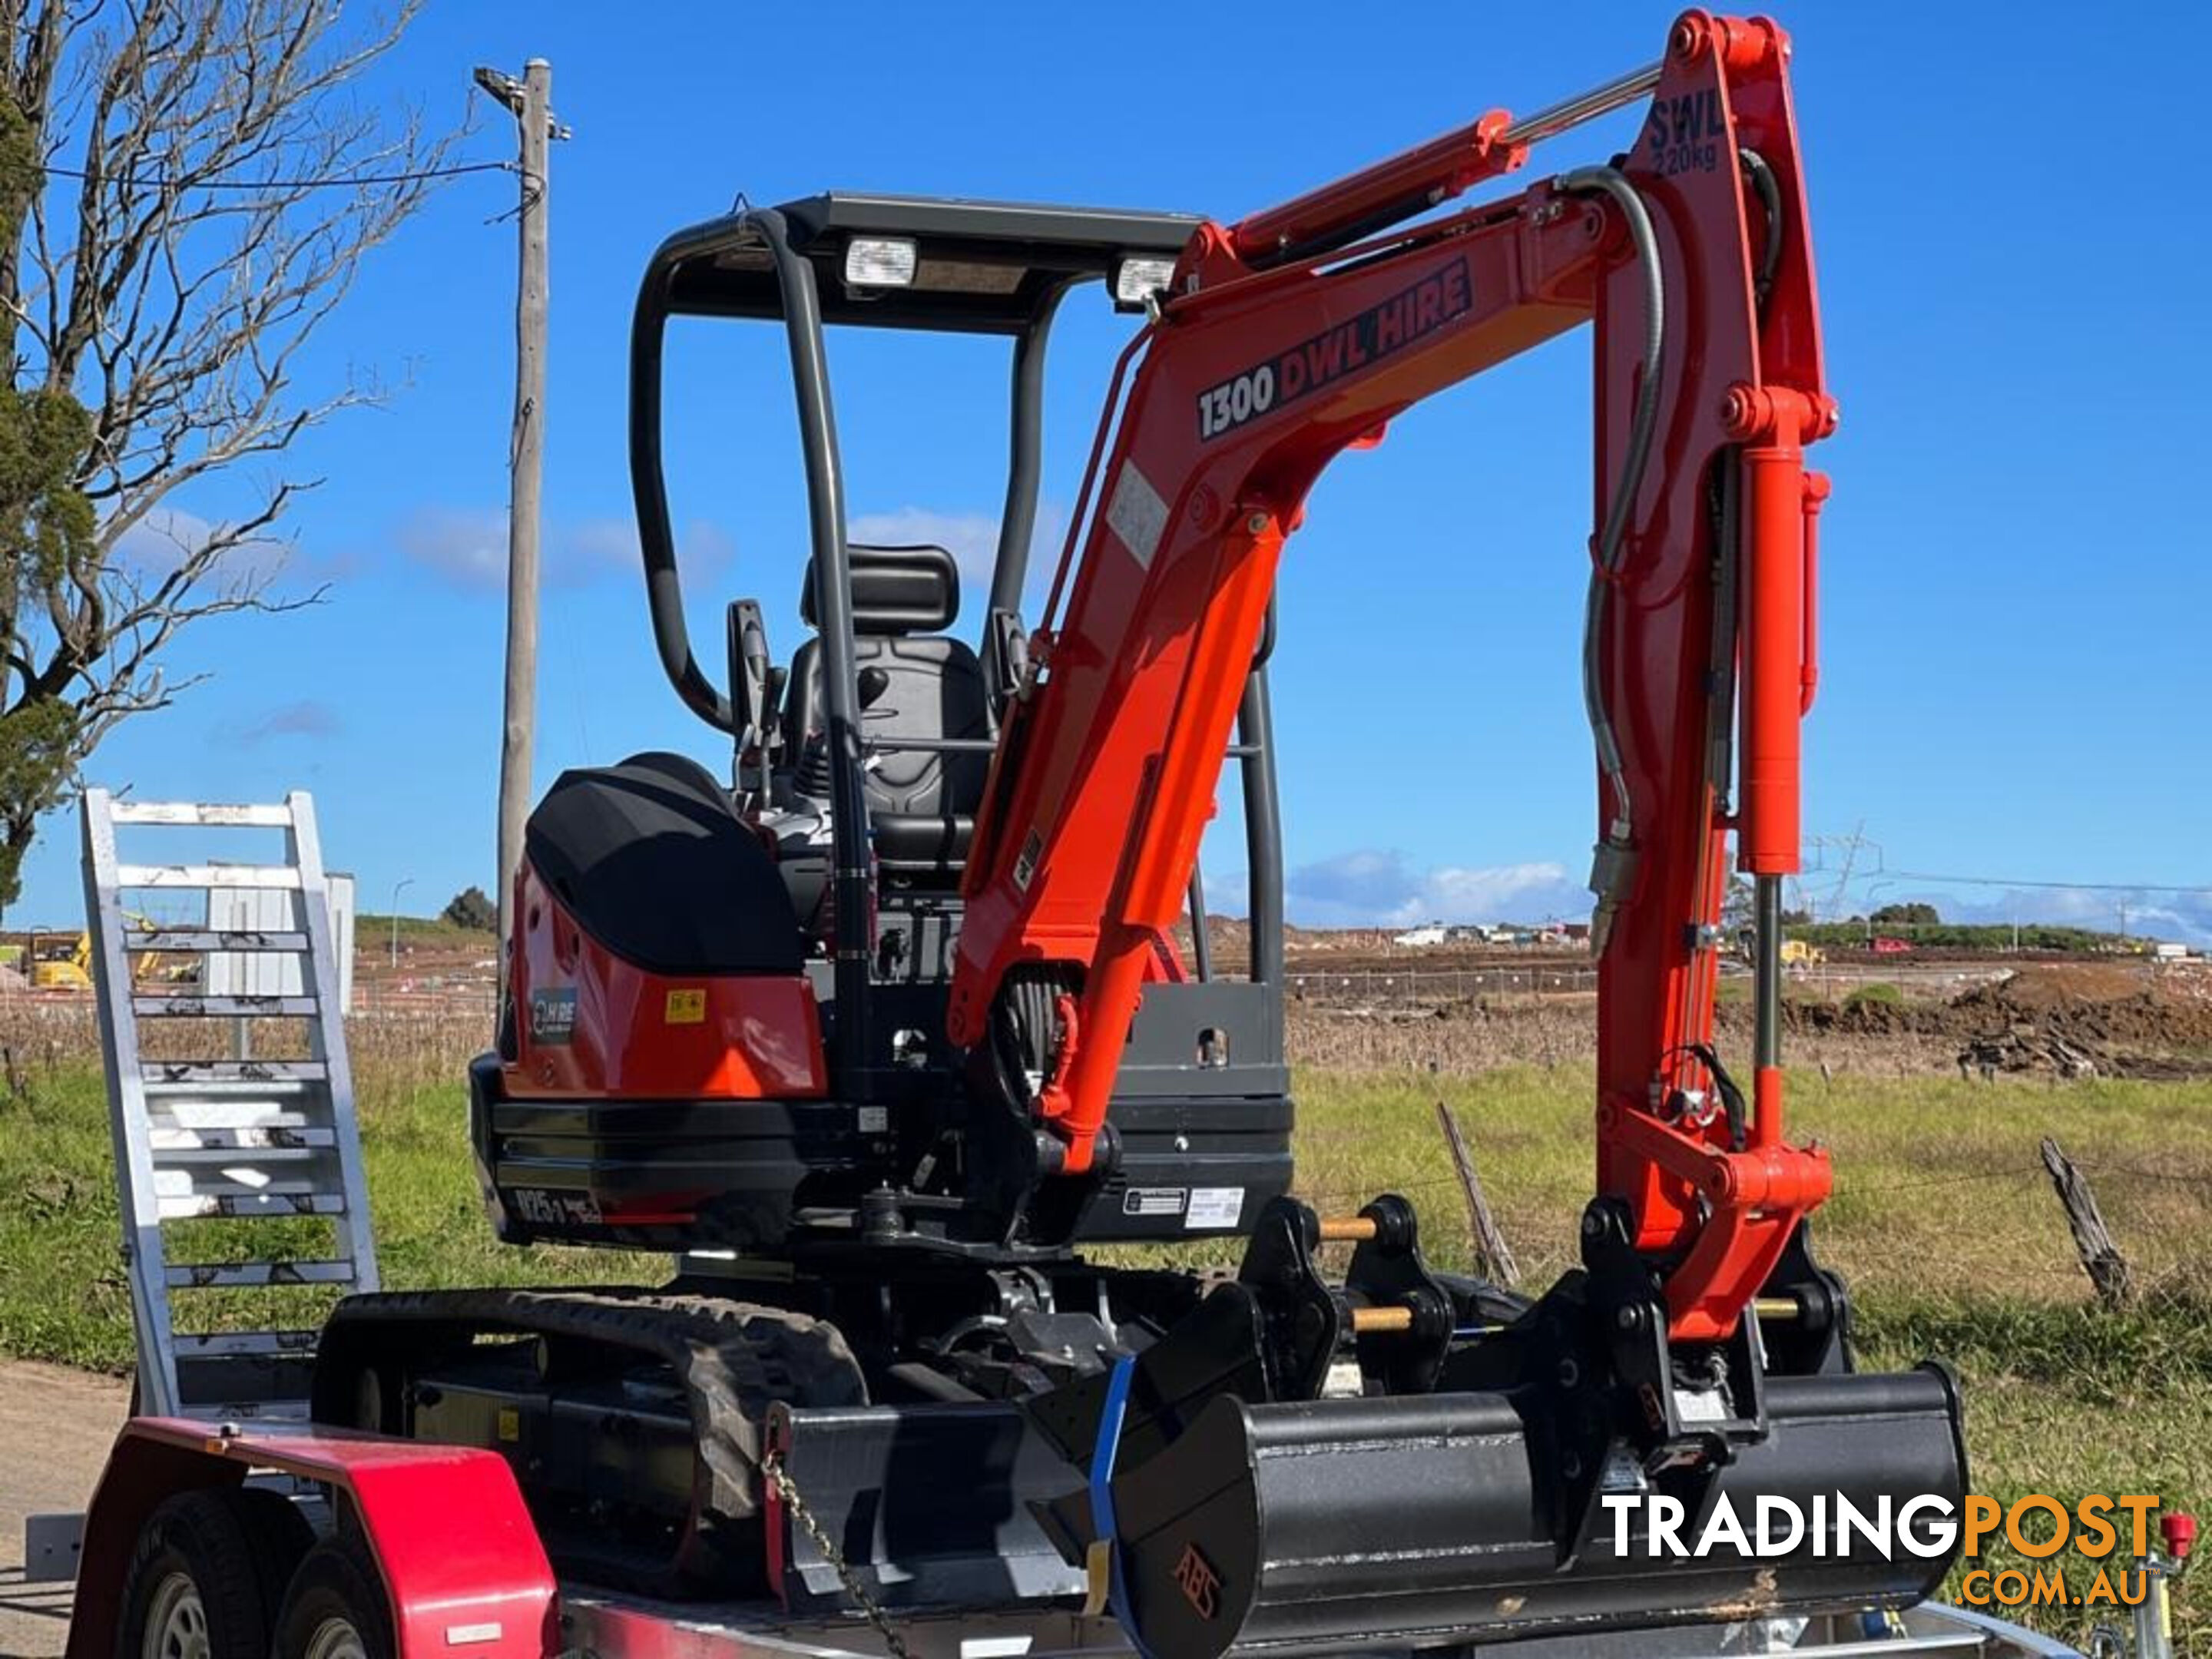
[0, 1026, 2212, 1650]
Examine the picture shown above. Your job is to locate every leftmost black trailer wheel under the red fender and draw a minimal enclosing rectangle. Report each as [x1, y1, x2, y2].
[115, 1491, 274, 1659]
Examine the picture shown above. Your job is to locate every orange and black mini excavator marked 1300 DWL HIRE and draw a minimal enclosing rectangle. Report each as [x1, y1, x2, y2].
[314, 11, 1964, 1659]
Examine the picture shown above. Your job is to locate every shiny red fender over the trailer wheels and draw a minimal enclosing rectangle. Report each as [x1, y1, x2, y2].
[66, 1418, 560, 1659]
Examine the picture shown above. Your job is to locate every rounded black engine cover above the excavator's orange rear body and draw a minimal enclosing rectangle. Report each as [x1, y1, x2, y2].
[525, 754, 803, 973]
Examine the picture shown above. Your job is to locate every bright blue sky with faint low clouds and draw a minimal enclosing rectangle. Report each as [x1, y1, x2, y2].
[9, 0, 2212, 938]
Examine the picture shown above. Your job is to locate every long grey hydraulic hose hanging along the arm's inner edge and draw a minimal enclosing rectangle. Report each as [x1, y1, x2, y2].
[1559, 166, 1666, 953]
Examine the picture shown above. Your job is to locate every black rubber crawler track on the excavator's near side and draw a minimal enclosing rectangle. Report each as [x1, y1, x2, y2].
[314, 1290, 867, 1579]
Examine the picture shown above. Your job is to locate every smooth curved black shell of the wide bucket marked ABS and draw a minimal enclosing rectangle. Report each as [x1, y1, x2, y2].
[1113, 1367, 1966, 1659]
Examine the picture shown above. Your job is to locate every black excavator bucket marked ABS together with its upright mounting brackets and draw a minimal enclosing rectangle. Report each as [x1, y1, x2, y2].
[1026, 1197, 1966, 1659]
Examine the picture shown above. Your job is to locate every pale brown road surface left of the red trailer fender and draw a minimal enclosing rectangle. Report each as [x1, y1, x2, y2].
[0, 1360, 131, 1659]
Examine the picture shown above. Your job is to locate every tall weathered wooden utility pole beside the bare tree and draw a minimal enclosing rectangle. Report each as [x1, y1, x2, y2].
[475, 58, 568, 993]
